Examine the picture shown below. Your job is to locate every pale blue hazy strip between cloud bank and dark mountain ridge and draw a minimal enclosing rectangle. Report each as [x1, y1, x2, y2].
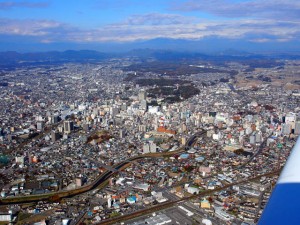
[0, 35, 300, 55]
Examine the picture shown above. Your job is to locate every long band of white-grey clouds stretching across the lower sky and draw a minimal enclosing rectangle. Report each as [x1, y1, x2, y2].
[0, 13, 300, 43]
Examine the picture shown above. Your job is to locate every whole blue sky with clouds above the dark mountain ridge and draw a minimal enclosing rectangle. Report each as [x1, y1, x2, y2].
[0, 0, 300, 51]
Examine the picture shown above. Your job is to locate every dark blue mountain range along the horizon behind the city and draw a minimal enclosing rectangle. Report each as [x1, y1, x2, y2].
[0, 48, 300, 67]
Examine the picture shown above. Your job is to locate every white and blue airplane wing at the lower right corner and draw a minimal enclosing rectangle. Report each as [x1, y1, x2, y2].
[258, 137, 300, 225]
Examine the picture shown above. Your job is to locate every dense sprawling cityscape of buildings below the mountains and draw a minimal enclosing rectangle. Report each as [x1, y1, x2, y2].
[0, 57, 300, 225]
